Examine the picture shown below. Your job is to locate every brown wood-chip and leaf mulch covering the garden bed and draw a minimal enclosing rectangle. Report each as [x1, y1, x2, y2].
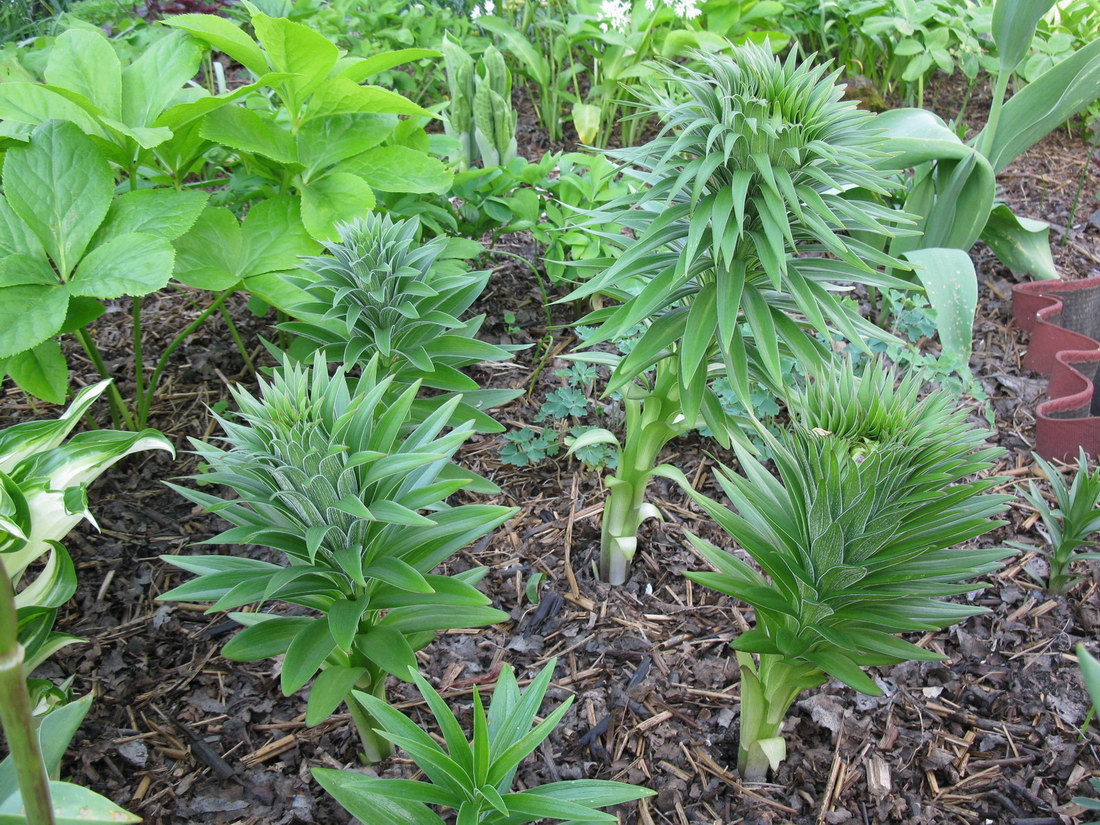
[0, 70, 1100, 825]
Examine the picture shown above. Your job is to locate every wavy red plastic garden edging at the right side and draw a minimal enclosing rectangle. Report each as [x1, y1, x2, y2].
[1012, 276, 1100, 461]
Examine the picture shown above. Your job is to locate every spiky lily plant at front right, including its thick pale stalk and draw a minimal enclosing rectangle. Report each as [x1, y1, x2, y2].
[664, 364, 1011, 780]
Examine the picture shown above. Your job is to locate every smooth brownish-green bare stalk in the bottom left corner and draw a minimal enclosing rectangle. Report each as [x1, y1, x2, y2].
[0, 573, 55, 825]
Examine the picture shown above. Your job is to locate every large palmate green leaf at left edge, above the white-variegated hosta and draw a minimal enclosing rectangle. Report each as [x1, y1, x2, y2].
[0, 120, 209, 403]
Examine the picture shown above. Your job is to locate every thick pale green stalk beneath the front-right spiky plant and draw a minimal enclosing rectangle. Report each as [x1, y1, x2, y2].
[737, 651, 825, 782]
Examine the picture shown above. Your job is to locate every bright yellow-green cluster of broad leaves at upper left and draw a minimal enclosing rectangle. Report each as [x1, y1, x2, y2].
[165, 7, 453, 240]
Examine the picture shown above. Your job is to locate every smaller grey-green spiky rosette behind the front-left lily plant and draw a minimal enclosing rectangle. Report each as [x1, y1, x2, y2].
[281, 212, 523, 432]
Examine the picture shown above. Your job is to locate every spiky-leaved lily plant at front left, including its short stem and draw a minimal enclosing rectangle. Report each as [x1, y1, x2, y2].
[164, 353, 514, 760]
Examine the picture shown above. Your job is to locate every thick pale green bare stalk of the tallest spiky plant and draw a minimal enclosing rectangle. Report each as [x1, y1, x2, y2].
[600, 358, 691, 584]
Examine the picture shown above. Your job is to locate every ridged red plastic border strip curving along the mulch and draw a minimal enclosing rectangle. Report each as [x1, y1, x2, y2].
[1012, 276, 1100, 461]
